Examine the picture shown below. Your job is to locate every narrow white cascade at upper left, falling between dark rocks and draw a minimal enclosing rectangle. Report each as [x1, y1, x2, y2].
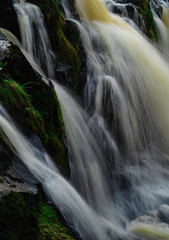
[14, 0, 54, 78]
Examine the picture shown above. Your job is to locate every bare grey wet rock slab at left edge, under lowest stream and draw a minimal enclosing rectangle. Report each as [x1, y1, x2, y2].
[0, 139, 38, 195]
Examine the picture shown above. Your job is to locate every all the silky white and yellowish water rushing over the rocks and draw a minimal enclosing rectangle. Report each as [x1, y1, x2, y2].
[0, 0, 169, 240]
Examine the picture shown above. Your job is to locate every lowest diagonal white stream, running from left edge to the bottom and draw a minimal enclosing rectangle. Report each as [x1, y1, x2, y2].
[0, 106, 116, 240]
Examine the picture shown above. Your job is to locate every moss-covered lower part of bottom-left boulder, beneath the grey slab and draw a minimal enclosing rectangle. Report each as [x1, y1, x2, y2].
[0, 191, 78, 240]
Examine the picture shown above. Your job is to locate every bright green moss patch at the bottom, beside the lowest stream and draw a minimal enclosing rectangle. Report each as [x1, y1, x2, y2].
[38, 200, 75, 240]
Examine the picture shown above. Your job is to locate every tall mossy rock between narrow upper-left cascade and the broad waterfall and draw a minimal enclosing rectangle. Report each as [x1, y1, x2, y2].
[30, 0, 86, 94]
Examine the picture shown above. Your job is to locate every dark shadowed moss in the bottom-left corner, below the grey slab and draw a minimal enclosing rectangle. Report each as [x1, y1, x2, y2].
[0, 192, 39, 240]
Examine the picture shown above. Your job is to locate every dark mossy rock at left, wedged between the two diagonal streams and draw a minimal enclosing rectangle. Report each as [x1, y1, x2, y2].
[0, 45, 69, 176]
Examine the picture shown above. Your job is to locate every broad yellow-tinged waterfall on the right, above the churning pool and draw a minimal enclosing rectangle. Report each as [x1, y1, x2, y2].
[72, 0, 169, 155]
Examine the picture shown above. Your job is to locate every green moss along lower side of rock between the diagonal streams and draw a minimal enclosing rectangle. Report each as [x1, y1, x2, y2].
[0, 76, 69, 174]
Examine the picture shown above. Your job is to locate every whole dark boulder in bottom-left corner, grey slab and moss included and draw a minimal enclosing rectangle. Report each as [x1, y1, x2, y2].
[0, 121, 75, 240]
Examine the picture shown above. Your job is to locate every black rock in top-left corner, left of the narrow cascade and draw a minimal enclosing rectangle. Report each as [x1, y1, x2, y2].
[0, 0, 20, 39]
